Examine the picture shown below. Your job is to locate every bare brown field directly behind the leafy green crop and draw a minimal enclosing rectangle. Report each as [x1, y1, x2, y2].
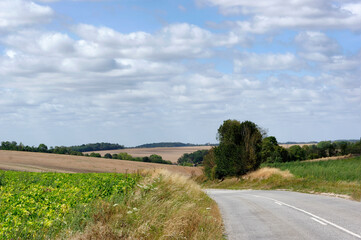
[0, 150, 202, 175]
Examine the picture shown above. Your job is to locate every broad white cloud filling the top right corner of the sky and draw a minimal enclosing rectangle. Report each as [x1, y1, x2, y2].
[198, 0, 361, 34]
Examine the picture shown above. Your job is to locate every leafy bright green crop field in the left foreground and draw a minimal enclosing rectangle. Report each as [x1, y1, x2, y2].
[0, 171, 140, 239]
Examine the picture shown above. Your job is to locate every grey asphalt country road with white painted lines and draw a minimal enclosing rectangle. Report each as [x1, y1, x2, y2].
[206, 189, 361, 240]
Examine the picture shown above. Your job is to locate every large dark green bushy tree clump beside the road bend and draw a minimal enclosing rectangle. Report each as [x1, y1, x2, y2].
[203, 120, 262, 179]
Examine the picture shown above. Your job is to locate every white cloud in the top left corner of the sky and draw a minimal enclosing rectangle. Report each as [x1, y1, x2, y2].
[0, 0, 54, 32]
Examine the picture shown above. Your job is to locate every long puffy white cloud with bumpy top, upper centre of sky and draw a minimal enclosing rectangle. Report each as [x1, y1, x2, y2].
[73, 23, 246, 59]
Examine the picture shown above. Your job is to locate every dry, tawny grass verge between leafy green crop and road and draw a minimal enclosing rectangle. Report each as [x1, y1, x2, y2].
[62, 170, 223, 240]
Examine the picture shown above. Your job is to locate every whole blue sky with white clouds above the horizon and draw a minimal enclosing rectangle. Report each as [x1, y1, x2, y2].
[0, 0, 361, 147]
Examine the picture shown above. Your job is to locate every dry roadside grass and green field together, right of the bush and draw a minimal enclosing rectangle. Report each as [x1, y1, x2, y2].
[198, 157, 361, 201]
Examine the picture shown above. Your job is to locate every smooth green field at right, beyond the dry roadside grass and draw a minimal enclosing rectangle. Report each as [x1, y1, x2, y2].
[263, 157, 361, 183]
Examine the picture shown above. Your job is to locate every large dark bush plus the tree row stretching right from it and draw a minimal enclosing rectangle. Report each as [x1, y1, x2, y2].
[203, 120, 361, 179]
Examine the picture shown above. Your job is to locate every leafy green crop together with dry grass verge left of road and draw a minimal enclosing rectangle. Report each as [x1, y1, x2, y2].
[0, 170, 223, 240]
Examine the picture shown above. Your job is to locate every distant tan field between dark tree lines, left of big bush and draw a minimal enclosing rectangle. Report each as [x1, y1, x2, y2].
[88, 146, 211, 163]
